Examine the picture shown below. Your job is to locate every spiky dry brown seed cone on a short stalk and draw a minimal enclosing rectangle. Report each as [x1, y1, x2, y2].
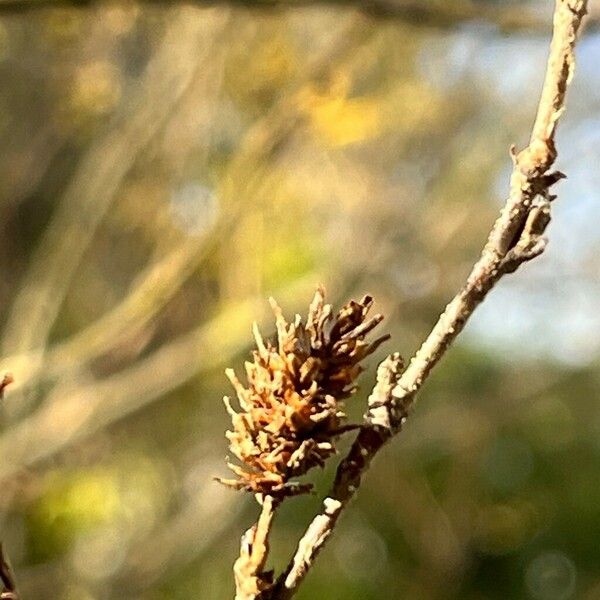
[219, 288, 389, 497]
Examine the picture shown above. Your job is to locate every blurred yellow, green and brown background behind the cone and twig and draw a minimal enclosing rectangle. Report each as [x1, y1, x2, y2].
[0, 0, 600, 600]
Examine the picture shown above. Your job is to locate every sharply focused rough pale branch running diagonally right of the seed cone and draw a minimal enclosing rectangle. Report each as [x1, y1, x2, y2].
[269, 0, 587, 600]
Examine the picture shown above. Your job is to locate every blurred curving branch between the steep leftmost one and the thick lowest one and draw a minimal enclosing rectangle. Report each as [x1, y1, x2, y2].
[0, 11, 370, 400]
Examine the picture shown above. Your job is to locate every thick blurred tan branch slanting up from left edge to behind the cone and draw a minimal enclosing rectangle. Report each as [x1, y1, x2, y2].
[0, 273, 319, 485]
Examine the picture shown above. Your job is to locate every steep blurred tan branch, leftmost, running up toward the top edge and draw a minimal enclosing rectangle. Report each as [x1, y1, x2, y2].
[3, 8, 224, 364]
